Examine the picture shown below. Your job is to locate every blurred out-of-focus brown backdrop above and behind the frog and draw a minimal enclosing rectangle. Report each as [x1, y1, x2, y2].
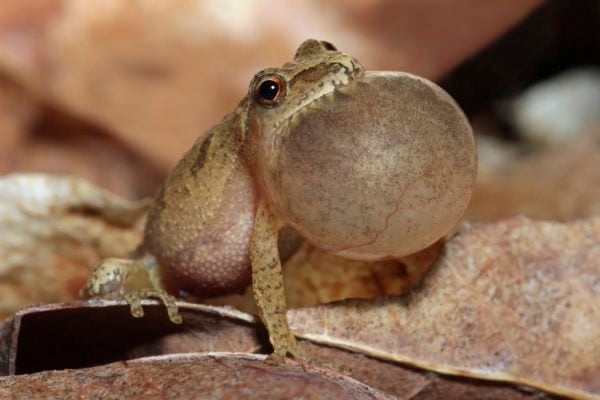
[0, 0, 600, 221]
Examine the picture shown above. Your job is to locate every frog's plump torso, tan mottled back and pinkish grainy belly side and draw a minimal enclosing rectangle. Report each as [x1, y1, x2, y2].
[144, 110, 256, 296]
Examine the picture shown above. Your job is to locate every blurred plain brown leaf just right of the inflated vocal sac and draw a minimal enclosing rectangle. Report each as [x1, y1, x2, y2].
[465, 129, 600, 221]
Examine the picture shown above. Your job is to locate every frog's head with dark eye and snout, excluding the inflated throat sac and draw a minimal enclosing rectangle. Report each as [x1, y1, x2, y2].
[248, 39, 364, 132]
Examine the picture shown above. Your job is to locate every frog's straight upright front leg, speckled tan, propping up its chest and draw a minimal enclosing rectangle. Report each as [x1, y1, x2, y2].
[250, 200, 309, 364]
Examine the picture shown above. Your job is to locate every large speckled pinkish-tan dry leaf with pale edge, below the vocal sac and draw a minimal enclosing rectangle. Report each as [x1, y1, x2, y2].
[289, 218, 600, 398]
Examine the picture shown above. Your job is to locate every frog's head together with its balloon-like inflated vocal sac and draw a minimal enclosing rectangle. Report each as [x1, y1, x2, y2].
[240, 40, 477, 260]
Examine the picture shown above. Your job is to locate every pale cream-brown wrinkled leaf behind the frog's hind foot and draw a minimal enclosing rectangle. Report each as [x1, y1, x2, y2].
[0, 174, 148, 317]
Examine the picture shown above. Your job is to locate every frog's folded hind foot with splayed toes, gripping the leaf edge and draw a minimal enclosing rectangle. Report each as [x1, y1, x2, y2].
[80, 256, 182, 324]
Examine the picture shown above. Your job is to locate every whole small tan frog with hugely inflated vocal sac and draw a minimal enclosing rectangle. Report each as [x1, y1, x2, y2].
[85, 40, 476, 361]
